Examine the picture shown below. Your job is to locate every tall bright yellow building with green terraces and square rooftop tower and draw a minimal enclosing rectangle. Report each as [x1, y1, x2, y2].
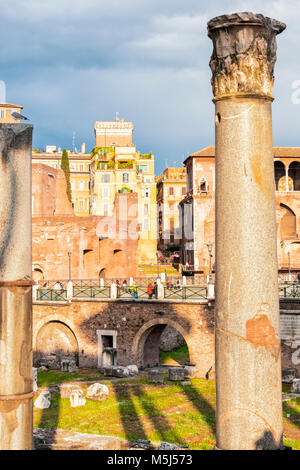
[90, 119, 157, 264]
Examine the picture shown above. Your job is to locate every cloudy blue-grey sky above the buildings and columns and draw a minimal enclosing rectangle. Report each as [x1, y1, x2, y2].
[0, 0, 300, 173]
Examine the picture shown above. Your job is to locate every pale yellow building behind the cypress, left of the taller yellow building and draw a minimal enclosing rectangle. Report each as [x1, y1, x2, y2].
[32, 147, 91, 217]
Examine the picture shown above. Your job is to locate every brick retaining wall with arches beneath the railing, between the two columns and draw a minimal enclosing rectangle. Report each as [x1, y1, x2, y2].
[33, 300, 214, 377]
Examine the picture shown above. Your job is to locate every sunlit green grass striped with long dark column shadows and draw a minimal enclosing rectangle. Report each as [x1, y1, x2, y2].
[34, 371, 300, 450]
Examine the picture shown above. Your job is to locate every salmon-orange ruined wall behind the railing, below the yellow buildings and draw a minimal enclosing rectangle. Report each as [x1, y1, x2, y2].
[32, 192, 138, 285]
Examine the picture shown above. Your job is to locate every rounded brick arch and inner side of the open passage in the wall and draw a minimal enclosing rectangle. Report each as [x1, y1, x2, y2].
[132, 318, 190, 366]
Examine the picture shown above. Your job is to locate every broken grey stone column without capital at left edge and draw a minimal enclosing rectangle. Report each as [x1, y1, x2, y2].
[0, 124, 33, 450]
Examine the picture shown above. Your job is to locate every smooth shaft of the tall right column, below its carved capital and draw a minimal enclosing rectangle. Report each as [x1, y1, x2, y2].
[216, 98, 282, 449]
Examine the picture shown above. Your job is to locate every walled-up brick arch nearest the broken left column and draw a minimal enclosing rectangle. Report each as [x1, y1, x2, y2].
[34, 320, 79, 369]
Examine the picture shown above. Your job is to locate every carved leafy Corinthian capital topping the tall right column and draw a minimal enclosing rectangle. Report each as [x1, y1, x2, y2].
[207, 12, 286, 99]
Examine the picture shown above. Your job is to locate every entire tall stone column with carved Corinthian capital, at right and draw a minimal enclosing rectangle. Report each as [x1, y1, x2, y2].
[208, 13, 285, 449]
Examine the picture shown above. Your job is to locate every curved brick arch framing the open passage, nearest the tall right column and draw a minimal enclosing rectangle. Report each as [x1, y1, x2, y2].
[132, 317, 191, 366]
